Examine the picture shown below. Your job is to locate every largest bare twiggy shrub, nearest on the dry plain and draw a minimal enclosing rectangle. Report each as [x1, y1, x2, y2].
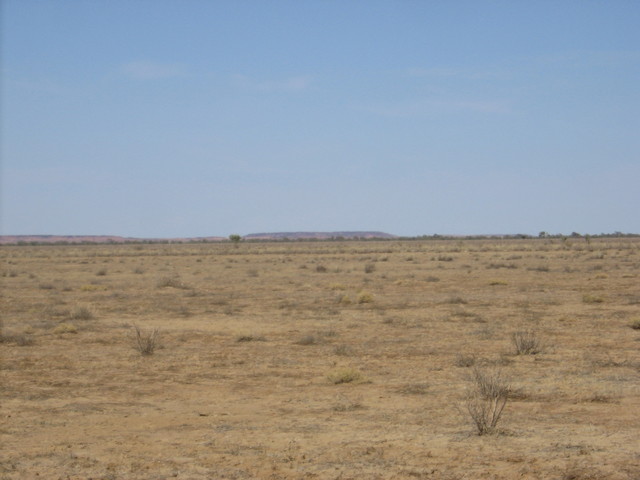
[466, 368, 510, 435]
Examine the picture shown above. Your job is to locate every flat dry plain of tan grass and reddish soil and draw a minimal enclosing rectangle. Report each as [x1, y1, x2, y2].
[0, 238, 640, 480]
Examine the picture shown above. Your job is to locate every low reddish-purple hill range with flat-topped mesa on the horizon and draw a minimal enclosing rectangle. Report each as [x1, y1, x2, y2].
[0, 232, 398, 245]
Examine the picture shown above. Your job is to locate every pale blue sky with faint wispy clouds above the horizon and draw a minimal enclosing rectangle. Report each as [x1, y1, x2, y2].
[0, 0, 640, 238]
